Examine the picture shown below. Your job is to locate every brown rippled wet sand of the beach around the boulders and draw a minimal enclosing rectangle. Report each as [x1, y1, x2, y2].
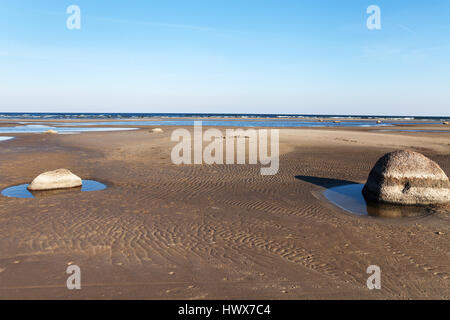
[0, 125, 450, 299]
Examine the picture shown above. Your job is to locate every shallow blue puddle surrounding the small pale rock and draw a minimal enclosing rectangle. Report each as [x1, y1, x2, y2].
[2, 180, 107, 198]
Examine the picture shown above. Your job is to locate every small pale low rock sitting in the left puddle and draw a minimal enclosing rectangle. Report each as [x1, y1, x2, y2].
[27, 169, 82, 191]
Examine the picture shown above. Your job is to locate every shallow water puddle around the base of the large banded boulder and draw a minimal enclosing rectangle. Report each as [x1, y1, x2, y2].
[323, 184, 432, 218]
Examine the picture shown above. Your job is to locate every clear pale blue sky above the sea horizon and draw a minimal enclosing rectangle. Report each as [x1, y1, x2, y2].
[0, 0, 450, 116]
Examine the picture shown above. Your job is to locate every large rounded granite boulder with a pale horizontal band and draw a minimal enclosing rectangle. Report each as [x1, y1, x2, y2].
[362, 150, 450, 205]
